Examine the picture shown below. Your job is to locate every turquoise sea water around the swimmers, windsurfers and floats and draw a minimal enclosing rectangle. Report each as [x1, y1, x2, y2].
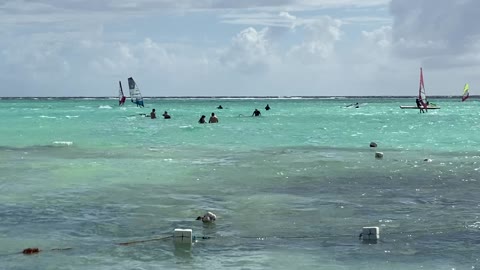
[0, 98, 480, 269]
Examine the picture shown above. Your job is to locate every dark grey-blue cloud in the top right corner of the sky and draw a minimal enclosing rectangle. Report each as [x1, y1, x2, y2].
[390, 0, 480, 67]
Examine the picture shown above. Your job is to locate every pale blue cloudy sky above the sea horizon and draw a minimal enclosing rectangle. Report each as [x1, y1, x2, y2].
[0, 0, 480, 97]
